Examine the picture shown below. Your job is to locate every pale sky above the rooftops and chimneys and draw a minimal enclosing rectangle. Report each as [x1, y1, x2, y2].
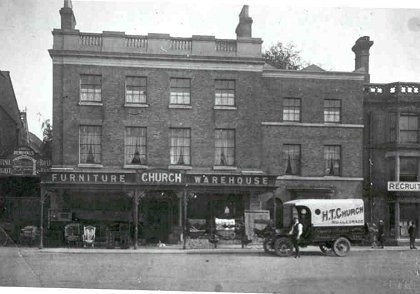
[0, 0, 420, 138]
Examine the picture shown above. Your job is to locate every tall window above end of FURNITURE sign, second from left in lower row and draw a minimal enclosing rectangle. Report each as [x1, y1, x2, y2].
[124, 127, 147, 165]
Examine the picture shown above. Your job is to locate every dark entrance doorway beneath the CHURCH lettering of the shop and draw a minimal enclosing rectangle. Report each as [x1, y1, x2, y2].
[140, 197, 173, 243]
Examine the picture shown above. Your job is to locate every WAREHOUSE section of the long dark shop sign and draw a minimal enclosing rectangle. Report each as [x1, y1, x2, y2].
[188, 175, 275, 186]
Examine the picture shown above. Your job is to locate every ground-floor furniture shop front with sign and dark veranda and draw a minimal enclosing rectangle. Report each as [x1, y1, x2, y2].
[40, 170, 275, 248]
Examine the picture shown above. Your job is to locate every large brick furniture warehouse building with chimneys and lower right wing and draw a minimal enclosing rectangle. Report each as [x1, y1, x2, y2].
[41, 1, 372, 246]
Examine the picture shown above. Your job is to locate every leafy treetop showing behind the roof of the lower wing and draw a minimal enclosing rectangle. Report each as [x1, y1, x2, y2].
[263, 42, 306, 70]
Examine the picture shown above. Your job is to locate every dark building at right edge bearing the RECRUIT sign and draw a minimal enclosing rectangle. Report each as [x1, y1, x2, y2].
[364, 82, 420, 243]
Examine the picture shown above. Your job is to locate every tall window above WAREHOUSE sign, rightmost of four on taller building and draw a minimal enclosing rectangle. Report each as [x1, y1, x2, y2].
[214, 129, 235, 166]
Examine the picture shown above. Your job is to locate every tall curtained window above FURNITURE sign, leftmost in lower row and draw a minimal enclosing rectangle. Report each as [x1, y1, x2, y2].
[79, 126, 102, 164]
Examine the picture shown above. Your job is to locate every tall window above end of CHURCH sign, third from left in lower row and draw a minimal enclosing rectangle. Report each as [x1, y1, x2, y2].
[170, 128, 191, 165]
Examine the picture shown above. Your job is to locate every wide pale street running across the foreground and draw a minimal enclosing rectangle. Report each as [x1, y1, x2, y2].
[0, 246, 420, 294]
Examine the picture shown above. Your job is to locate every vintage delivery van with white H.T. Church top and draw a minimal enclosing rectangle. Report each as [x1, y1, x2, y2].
[273, 199, 366, 256]
